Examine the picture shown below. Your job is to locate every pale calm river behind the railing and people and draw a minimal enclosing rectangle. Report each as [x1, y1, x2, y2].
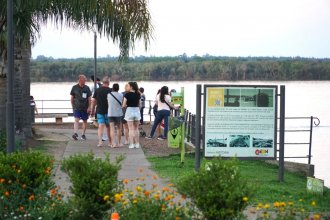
[31, 81, 330, 186]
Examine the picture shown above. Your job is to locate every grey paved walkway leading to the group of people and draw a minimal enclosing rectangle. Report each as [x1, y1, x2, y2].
[40, 128, 167, 195]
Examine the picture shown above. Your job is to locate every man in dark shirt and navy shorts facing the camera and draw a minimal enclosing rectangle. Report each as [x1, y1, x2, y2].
[70, 75, 92, 140]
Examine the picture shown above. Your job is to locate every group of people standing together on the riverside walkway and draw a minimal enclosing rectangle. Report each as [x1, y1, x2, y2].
[70, 75, 175, 148]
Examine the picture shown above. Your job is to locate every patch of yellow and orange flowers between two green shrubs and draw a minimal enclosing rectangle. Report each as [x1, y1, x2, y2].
[109, 171, 200, 220]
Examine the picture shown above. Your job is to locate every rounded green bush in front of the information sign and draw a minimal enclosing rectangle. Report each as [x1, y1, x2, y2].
[178, 159, 250, 220]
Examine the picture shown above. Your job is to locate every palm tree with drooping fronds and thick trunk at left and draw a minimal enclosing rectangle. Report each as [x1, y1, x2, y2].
[0, 0, 152, 136]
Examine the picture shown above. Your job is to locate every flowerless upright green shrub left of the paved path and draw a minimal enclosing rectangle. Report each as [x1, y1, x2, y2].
[62, 154, 122, 219]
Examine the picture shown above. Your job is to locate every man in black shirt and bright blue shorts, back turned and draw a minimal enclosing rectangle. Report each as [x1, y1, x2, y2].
[92, 76, 111, 147]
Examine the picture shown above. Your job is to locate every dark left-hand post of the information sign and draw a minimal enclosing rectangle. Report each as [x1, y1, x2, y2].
[195, 84, 202, 171]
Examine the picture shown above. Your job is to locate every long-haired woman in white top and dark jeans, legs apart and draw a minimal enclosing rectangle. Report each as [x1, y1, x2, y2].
[146, 86, 175, 140]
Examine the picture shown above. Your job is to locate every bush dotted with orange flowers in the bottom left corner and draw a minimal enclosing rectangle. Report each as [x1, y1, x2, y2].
[0, 152, 67, 219]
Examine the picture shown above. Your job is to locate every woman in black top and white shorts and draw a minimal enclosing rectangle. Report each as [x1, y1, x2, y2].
[123, 82, 141, 148]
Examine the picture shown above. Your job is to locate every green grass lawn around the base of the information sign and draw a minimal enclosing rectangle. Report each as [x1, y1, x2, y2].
[148, 154, 330, 212]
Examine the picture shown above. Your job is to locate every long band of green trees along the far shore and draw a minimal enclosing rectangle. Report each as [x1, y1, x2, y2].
[30, 54, 330, 82]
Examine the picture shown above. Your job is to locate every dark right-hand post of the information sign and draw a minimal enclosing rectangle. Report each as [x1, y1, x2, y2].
[278, 86, 285, 182]
